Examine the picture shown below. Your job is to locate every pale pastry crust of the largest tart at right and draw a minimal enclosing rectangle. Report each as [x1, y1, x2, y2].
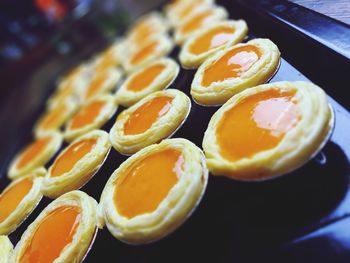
[203, 81, 334, 181]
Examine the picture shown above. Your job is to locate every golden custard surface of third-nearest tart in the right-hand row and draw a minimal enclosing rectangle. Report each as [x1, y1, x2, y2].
[189, 27, 234, 55]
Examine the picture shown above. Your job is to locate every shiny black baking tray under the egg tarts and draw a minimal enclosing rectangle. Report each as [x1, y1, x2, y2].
[0, 0, 350, 262]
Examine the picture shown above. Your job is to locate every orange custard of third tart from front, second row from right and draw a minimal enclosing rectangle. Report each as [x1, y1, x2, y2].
[127, 64, 165, 91]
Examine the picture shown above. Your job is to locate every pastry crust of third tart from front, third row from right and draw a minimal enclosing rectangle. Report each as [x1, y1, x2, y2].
[64, 95, 117, 142]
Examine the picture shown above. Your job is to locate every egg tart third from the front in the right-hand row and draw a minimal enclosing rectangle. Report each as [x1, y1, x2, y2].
[179, 20, 248, 69]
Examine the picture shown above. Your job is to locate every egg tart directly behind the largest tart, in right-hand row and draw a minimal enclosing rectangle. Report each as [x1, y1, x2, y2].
[191, 39, 280, 105]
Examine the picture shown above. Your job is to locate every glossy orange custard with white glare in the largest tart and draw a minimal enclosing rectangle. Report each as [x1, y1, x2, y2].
[216, 89, 300, 161]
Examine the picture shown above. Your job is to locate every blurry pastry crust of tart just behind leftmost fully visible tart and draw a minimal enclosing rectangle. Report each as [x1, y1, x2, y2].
[34, 100, 78, 138]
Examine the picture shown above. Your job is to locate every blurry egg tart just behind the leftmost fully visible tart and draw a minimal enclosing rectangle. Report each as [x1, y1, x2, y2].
[34, 100, 77, 138]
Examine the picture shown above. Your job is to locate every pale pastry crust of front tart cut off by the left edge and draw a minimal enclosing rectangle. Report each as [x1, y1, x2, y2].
[0, 170, 46, 235]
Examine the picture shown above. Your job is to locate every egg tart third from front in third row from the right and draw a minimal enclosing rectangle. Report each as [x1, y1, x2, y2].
[64, 95, 117, 142]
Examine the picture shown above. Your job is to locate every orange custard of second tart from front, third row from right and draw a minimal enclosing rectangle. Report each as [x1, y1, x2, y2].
[51, 138, 97, 177]
